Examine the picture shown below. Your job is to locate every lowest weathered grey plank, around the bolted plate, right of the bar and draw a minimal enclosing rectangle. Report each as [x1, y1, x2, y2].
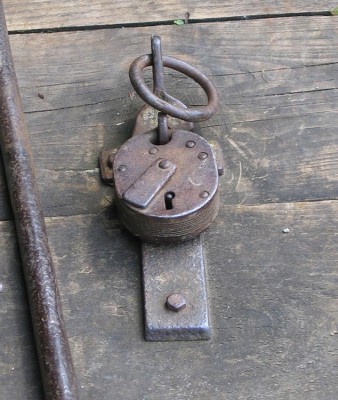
[0, 201, 338, 400]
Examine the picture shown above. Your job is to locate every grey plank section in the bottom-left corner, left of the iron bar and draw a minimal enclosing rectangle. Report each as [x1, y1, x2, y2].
[0, 222, 43, 400]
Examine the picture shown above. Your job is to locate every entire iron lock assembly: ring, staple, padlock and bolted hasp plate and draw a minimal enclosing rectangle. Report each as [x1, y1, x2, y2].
[100, 36, 224, 341]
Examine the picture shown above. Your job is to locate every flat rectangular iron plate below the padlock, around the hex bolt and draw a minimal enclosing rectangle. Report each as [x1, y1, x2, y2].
[141, 237, 210, 341]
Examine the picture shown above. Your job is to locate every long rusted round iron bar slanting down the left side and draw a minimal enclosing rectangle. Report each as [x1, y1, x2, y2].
[0, 0, 78, 400]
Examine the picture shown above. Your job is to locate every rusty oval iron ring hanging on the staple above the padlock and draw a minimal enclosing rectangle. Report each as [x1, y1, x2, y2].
[129, 54, 218, 122]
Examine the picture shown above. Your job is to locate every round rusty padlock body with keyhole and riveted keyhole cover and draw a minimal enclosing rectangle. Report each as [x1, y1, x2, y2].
[113, 130, 219, 242]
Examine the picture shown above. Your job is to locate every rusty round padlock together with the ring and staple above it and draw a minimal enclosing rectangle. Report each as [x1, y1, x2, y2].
[101, 36, 223, 242]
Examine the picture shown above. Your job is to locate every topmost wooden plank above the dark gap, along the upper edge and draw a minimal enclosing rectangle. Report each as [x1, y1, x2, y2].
[4, 0, 337, 30]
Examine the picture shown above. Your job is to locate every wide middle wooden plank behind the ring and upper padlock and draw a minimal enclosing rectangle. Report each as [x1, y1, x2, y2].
[0, 17, 338, 219]
